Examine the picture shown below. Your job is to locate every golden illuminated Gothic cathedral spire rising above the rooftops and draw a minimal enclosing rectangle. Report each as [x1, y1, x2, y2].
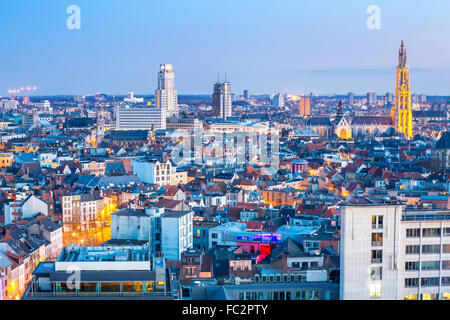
[391, 41, 413, 138]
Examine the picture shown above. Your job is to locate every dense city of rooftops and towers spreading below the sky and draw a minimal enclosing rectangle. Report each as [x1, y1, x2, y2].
[0, 0, 450, 306]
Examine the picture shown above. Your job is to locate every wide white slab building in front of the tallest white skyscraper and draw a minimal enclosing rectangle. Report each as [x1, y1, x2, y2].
[116, 106, 167, 130]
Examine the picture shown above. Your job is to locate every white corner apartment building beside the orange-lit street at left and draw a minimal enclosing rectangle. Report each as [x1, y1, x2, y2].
[61, 194, 104, 232]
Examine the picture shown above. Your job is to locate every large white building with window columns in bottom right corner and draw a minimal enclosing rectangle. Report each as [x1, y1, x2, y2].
[340, 201, 450, 300]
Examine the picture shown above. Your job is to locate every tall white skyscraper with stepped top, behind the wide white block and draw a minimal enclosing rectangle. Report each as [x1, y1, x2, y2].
[155, 64, 178, 116]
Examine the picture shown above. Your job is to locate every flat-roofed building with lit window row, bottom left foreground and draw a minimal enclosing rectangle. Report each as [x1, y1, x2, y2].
[23, 245, 172, 300]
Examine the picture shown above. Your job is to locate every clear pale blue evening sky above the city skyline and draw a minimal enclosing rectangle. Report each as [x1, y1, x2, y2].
[0, 0, 450, 96]
